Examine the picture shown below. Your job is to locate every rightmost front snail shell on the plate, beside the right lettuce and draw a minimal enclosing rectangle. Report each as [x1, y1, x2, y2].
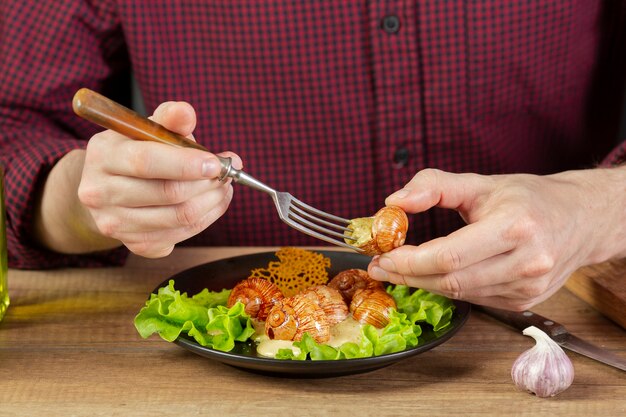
[350, 288, 396, 329]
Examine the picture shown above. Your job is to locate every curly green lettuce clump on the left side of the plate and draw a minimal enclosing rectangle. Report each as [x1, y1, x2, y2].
[134, 280, 254, 351]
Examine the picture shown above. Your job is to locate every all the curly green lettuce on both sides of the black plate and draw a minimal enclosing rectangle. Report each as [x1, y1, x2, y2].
[135, 280, 455, 360]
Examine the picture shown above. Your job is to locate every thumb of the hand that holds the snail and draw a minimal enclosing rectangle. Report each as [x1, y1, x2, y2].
[385, 168, 491, 213]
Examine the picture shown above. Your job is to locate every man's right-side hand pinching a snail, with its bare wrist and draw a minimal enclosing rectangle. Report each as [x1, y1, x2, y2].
[369, 167, 626, 310]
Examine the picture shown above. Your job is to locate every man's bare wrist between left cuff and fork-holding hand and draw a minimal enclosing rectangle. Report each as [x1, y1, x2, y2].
[32, 150, 121, 254]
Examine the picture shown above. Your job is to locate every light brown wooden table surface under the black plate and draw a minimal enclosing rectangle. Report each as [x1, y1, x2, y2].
[0, 248, 626, 417]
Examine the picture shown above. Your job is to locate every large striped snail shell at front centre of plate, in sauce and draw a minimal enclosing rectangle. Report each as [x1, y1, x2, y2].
[265, 294, 330, 343]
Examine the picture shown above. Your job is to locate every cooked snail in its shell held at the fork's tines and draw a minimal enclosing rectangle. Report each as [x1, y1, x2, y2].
[344, 206, 409, 256]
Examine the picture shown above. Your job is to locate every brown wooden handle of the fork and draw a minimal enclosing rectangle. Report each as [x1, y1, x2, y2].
[72, 88, 233, 179]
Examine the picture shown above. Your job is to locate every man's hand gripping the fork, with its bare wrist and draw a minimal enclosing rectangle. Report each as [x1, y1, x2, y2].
[35, 102, 242, 257]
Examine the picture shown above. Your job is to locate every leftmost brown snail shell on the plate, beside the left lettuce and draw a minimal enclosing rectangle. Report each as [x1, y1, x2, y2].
[226, 277, 284, 321]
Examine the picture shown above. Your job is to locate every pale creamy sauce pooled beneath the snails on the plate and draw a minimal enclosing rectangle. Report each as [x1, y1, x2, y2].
[252, 316, 370, 358]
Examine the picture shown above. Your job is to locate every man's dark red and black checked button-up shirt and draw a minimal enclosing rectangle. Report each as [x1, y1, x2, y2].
[0, 0, 626, 268]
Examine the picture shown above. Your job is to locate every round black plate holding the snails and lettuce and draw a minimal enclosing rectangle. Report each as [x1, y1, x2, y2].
[154, 251, 470, 378]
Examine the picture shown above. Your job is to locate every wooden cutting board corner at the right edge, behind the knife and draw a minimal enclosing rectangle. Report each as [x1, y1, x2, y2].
[565, 258, 626, 329]
